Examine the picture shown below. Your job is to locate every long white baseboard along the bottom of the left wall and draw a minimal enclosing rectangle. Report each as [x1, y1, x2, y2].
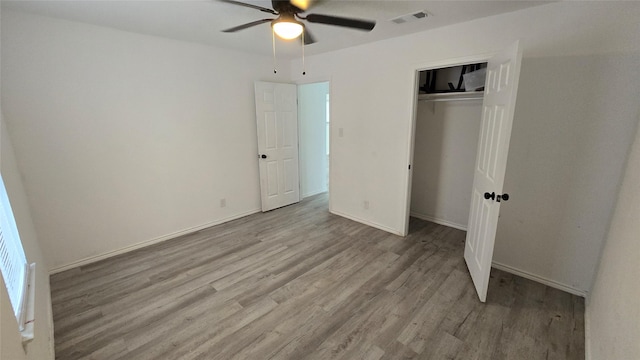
[49, 209, 261, 275]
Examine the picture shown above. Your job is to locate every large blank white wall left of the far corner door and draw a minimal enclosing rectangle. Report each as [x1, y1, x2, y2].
[2, 11, 288, 270]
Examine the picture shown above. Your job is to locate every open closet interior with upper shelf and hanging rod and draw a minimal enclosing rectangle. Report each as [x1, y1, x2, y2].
[410, 62, 487, 231]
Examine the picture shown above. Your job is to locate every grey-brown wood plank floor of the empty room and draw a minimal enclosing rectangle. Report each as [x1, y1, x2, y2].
[51, 194, 584, 360]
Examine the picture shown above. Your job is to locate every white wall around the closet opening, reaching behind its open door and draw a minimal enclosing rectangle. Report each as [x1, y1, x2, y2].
[291, 2, 640, 292]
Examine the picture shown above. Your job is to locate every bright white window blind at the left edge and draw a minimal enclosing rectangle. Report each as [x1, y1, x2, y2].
[0, 176, 27, 329]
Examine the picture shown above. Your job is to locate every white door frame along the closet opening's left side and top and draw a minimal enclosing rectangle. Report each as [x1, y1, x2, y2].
[401, 52, 496, 236]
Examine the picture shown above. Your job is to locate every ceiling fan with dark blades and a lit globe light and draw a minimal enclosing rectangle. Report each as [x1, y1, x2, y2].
[219, 0, 376, 45]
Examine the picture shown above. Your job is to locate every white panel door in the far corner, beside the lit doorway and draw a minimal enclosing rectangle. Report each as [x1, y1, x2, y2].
[255, 81, 300, 211]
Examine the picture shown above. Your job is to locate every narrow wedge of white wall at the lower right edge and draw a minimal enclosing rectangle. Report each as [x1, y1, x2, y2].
[585, 117, 640, 360]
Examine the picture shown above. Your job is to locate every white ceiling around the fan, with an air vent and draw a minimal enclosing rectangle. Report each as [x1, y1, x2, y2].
[2, 0, 549, 57]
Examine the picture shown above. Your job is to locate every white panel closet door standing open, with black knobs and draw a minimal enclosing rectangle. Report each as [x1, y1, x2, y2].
[464, 42, 522, 302]
